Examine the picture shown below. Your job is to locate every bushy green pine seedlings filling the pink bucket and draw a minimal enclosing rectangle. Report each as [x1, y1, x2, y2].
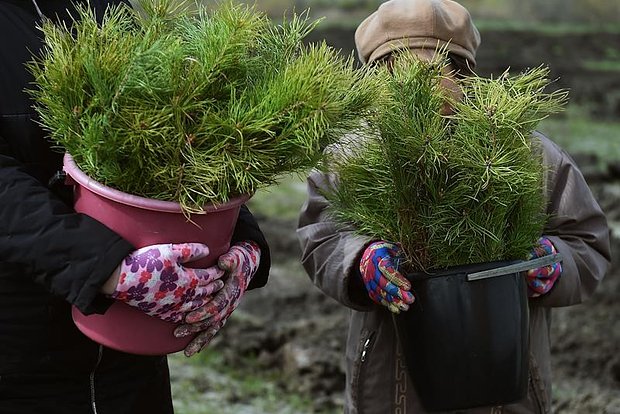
[29, 0, 378, 212]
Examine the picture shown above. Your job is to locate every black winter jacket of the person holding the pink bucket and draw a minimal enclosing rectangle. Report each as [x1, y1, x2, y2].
[0, 0, 270, 414]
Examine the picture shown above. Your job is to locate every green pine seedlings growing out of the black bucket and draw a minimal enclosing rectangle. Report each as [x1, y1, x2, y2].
[327, 54, 566, 271]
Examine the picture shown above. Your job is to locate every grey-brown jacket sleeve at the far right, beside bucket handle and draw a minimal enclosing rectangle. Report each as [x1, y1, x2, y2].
[533, 134, 611, 307]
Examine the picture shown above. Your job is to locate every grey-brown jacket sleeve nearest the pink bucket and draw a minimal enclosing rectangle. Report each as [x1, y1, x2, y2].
[297, 171, 373, 311]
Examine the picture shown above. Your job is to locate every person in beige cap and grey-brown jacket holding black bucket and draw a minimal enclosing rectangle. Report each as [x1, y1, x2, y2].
[297, 0, 610, 414]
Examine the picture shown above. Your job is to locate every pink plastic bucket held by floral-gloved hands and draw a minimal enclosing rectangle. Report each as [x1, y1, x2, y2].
[64, 154, 249, 355]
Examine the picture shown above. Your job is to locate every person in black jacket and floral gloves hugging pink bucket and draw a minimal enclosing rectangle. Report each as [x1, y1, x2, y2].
[0, 0, 270, 414]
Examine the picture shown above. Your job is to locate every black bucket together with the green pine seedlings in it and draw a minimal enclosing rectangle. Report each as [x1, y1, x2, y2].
[326, 53, 566, 411]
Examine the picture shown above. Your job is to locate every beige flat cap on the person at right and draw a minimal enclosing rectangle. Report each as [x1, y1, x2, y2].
[355, 0, 480, 69]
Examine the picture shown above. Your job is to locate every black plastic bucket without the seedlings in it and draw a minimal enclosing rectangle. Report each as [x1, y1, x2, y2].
[394, 261, 529, 411]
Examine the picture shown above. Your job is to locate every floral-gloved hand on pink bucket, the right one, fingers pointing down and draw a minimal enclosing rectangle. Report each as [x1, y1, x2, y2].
[174, 241, 260, 357]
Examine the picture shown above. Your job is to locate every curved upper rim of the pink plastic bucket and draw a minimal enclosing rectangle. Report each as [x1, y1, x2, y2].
[63, 152, 251, 214]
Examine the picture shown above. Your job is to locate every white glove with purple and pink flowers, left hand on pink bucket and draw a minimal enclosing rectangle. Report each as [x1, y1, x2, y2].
[111, 243, 224, 323]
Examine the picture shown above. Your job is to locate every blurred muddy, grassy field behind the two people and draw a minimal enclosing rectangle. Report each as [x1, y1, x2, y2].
[170, 0, 620, 414]
